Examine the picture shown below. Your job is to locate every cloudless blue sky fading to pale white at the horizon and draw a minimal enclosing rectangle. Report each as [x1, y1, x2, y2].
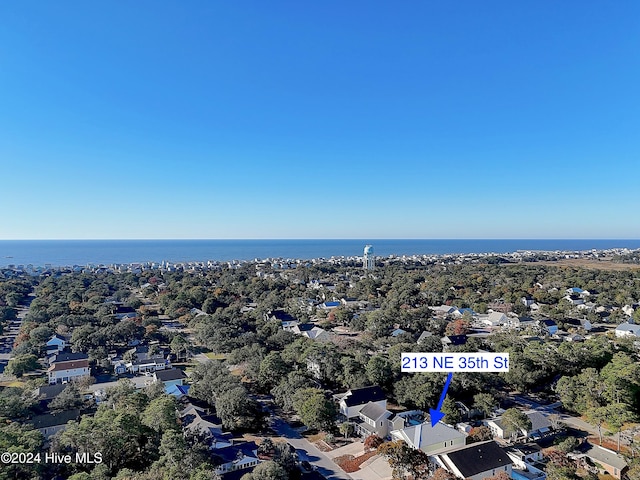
[0, 0, 640, 239]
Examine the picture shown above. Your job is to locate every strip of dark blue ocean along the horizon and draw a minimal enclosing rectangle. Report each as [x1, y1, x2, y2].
[0, 239, 640, 267]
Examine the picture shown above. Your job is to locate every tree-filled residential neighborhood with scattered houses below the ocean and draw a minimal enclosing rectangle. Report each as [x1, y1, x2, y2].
[0, 248, 640, 480]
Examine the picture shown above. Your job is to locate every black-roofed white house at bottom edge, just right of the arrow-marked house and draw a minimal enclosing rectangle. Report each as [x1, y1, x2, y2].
[432, 440, 513, 480]
